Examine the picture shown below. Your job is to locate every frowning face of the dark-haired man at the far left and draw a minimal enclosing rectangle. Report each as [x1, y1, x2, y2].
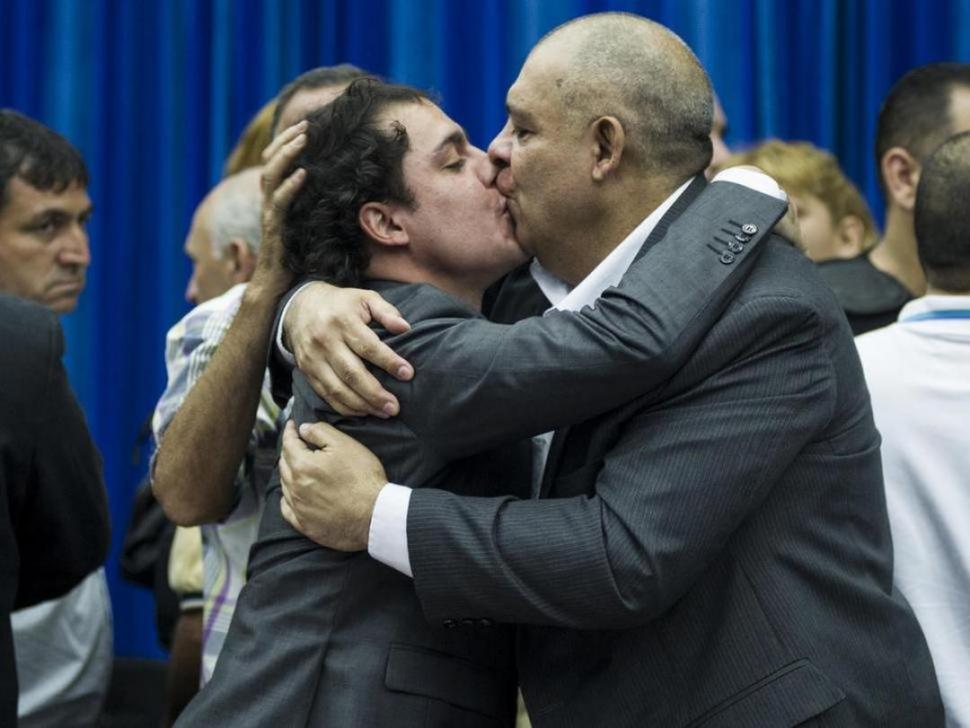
[0, 177, 92, 313]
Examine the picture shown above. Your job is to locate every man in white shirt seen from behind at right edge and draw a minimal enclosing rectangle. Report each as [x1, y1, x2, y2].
[856, 132, 970, 726]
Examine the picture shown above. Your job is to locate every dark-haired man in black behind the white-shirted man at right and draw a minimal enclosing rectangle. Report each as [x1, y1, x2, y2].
[819, 63, 970, 334]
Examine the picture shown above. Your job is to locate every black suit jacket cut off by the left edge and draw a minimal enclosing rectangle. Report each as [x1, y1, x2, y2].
[0, 295, 109, 726]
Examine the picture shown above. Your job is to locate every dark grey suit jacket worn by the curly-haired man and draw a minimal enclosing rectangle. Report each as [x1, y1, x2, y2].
[179, 178, 785, 726]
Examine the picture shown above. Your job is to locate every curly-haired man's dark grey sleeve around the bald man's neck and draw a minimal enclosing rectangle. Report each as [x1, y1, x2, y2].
[385, 182, 786, 459]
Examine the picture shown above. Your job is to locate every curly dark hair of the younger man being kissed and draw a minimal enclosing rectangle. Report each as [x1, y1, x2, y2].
[283, 78, 429, 285]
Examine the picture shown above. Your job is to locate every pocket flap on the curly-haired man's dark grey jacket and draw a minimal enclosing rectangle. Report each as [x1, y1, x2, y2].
[384, 645, 511, 719]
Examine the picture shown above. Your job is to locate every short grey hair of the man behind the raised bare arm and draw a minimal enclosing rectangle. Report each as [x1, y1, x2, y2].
[207, 167, 262, 257]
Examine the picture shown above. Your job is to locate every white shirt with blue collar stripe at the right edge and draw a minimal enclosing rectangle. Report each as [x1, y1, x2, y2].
[856, 296, 970, 726]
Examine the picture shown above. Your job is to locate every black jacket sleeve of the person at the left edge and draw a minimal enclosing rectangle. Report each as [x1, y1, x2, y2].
[15, 316, 110, 609]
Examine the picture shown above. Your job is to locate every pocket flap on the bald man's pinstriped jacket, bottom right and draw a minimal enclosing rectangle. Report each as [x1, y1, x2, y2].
[690, 660, 845, 728]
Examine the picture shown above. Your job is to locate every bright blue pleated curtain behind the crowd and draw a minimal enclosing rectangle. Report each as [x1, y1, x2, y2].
[0, 0, 970, 655]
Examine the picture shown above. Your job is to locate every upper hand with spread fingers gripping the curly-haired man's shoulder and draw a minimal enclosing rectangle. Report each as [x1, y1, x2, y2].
[283, 282, 414, 418]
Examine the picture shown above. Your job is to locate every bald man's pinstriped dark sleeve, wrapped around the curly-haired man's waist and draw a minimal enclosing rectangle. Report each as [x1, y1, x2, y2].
[408, 297, 835, 628]
